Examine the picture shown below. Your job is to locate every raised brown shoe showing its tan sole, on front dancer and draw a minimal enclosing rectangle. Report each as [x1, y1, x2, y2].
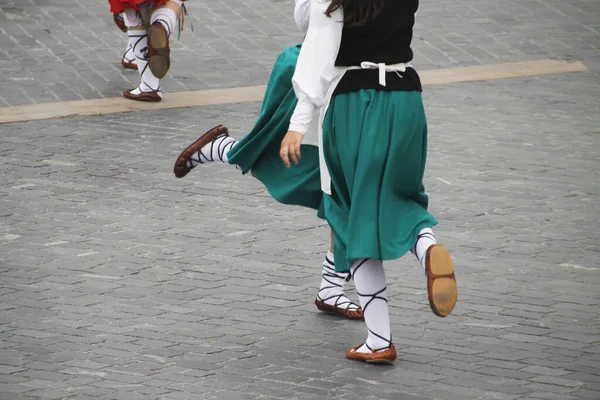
[425, 244, 458, 317]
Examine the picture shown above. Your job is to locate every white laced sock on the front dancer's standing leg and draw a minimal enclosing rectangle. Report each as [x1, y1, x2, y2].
[350, 258, 392, 353]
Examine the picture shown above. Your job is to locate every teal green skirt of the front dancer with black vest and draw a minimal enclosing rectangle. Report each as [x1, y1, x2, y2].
[323, 89, 437, 272]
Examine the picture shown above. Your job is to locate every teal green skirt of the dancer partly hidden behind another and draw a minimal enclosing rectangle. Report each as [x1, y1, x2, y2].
[227, 46, 323, 217]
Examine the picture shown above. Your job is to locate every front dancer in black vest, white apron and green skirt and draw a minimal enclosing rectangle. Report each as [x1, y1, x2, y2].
[280, 0, 458, 363]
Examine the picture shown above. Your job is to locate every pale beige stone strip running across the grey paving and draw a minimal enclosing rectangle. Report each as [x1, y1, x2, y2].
[0, 59, 586, 124]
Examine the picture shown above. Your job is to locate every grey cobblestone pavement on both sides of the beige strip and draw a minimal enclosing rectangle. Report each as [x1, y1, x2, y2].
[0, 0, 600, 400]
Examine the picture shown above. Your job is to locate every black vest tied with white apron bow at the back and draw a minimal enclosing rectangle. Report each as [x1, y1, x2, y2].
[335, 0, 421, 94]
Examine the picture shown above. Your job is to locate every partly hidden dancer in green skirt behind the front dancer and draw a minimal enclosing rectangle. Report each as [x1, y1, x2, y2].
[174, 0, 363, 320]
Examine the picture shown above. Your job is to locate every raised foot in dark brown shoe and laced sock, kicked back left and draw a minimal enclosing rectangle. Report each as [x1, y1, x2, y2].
[173, 125, 236, 178]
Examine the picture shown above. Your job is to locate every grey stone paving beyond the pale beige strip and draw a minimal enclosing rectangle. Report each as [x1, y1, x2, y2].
[0, 0, 600, 105]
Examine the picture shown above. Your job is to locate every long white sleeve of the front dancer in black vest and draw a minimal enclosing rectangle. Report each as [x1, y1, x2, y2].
[289, 0, 344, 134]
